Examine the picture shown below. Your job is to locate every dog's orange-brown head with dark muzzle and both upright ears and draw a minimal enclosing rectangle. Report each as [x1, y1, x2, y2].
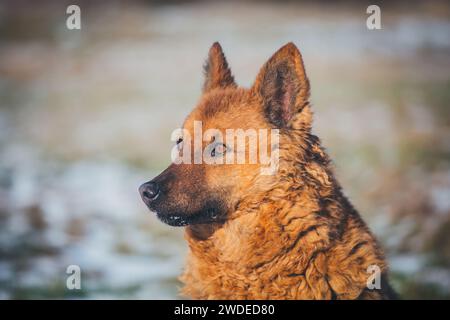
[139, 43, 311, 226]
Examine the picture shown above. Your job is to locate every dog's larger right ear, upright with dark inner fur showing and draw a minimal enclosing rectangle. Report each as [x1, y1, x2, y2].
[252, 42, 310, 128]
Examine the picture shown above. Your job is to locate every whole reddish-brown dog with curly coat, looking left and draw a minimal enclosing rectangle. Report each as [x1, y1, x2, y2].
[139, 43, 395, 299]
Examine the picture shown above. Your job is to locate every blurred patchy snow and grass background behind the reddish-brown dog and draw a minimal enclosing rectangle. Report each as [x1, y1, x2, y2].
[0, 1, 450, 299]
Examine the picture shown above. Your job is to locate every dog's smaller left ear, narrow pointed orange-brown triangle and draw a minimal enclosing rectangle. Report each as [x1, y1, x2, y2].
[203, 42, 236, 93]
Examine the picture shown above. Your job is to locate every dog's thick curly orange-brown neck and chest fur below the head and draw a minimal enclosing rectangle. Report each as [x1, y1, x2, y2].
[181, 174, 387, 299]
